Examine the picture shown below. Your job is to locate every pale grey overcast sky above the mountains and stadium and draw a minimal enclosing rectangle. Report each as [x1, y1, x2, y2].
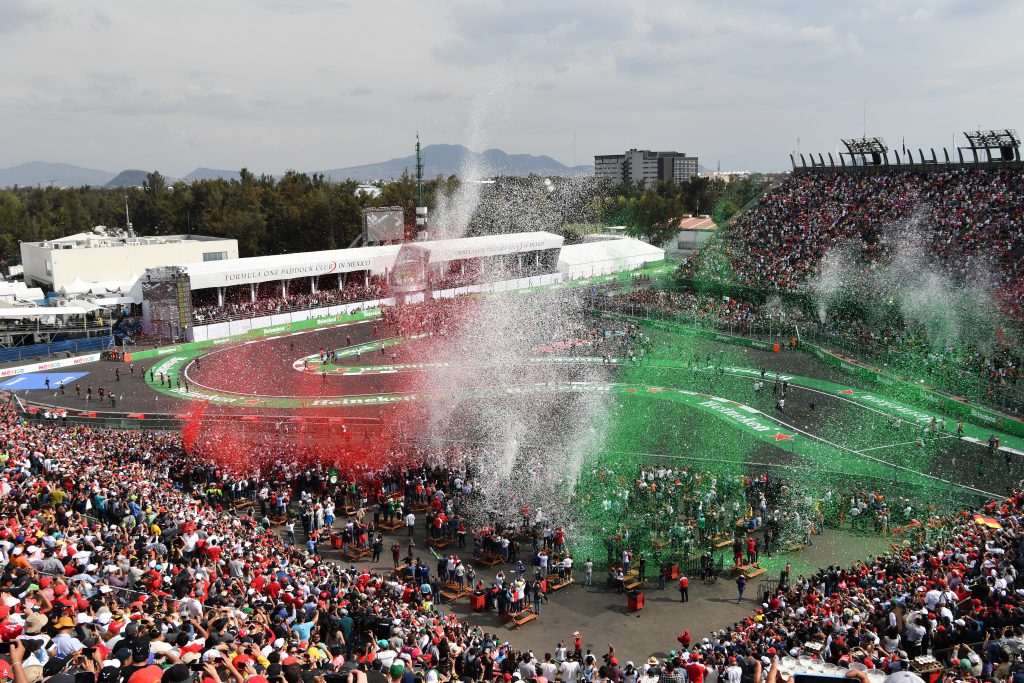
[0, 0, 1024, 176]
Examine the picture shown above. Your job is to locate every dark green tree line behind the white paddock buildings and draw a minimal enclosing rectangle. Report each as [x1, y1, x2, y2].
[0, 169, 766, 263]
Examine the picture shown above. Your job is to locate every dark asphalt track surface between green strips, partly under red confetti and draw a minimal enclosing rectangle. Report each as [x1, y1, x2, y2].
[18, 322, 1024, 493]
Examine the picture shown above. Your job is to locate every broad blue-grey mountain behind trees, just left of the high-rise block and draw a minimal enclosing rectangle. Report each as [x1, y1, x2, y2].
[323, 144, 593, 180]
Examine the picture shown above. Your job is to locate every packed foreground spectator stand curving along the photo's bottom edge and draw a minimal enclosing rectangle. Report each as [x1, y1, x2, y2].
[6, 409, 1024, 683]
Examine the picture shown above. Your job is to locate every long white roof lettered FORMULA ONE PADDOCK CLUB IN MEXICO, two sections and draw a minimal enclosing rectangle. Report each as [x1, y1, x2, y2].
[180, 232, 563, 290]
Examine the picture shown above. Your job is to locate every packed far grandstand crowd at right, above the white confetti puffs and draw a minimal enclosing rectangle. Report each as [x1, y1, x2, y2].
[691, 168, 1024, 312]
